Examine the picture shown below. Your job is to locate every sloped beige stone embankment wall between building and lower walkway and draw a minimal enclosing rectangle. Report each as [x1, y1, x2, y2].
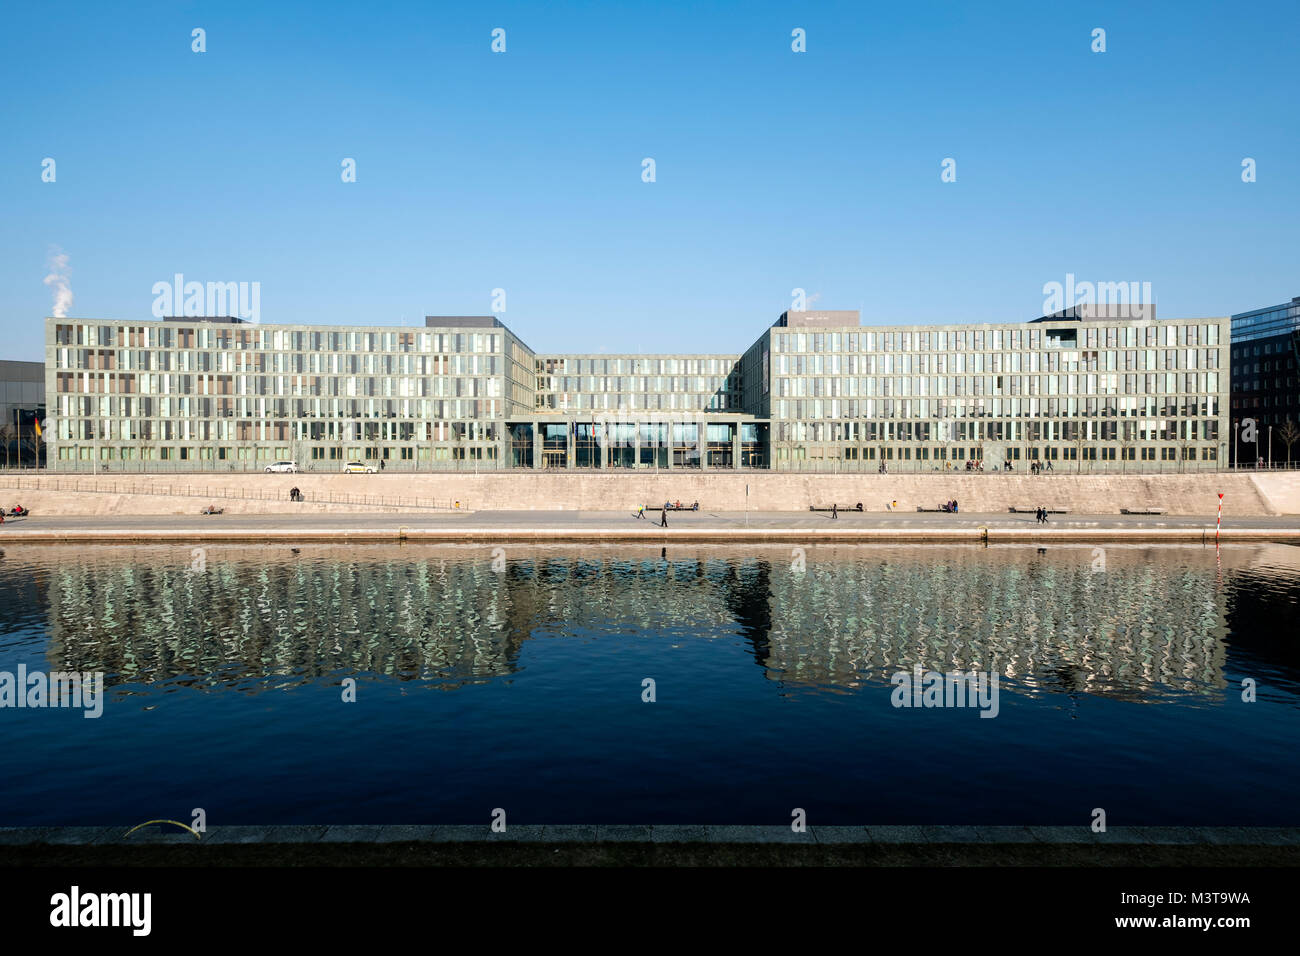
[0, 471, 1300, 518]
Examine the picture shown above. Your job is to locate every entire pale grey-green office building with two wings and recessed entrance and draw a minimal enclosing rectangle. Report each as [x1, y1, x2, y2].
[46, 307, 1231, 471]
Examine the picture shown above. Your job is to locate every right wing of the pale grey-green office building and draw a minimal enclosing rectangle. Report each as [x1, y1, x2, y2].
[741, 306, 1229, 471]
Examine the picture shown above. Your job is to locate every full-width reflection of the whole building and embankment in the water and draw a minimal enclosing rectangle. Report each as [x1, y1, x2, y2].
[17, 545, 1300, 698]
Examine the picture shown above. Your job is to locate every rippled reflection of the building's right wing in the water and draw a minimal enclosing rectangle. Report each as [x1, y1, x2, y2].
[767, 548, 1225, 695]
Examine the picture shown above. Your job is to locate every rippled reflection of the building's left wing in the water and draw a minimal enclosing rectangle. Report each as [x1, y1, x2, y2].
[48, 549, 527, 685]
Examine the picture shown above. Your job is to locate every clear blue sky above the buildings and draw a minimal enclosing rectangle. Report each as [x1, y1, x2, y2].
[0, 0, 1300, 359]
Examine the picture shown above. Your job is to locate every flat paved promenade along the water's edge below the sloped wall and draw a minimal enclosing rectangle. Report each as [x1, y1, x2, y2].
[0, 510, 1300, 545]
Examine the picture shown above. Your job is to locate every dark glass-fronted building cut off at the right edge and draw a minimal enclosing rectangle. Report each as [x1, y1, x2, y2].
[1231, 295, 1300, 464]
